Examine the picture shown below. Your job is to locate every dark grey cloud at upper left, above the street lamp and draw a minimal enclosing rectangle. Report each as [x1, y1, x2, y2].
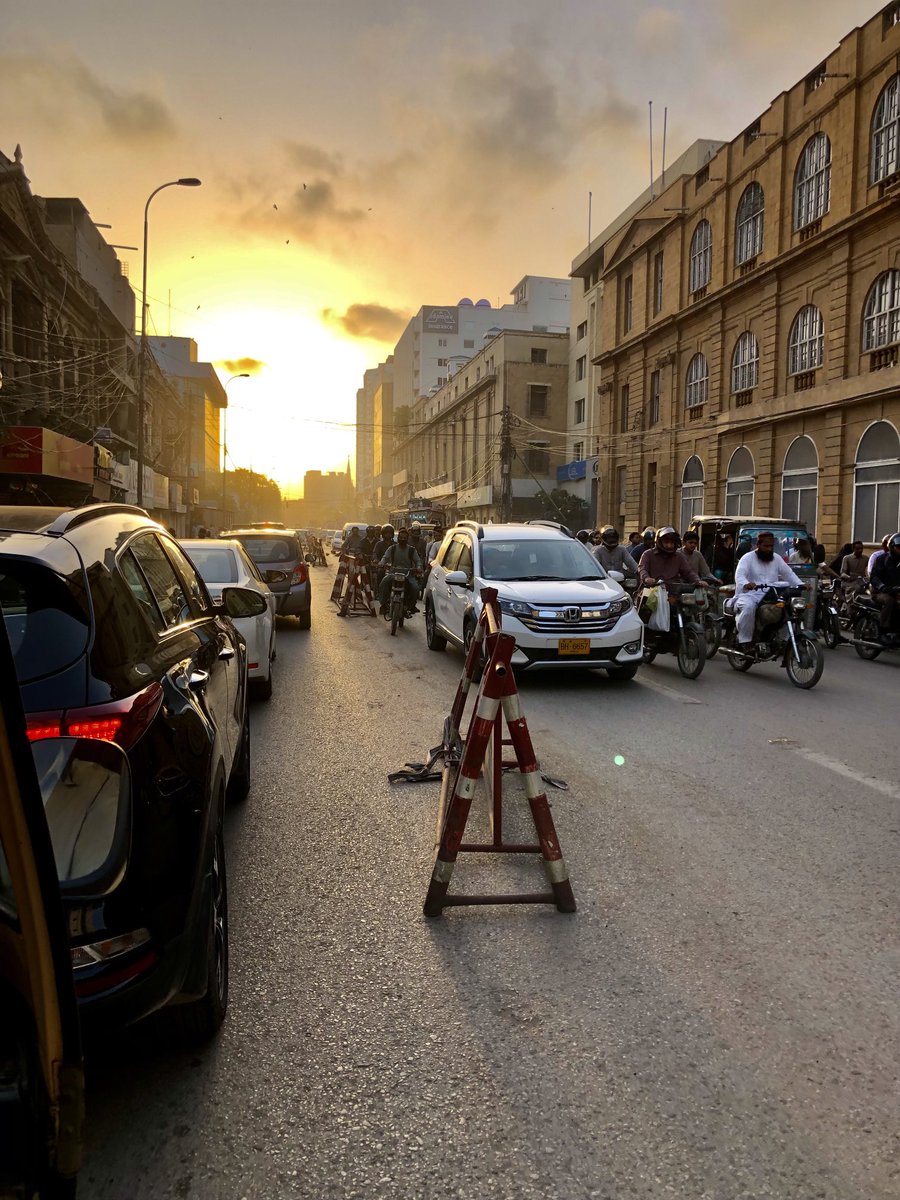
[0, 54, 176, 143]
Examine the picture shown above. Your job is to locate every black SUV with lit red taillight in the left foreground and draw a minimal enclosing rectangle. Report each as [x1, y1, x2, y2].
[0, 504, 265, 1038]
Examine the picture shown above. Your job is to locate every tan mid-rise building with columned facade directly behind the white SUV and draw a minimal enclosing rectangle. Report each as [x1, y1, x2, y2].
[392, 330, 569, 530]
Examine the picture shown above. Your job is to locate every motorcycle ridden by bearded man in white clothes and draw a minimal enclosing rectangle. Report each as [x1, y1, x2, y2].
[720, 583, 824, 690]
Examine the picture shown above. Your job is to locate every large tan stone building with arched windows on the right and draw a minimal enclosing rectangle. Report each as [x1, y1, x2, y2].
[588, 2, 900, 550]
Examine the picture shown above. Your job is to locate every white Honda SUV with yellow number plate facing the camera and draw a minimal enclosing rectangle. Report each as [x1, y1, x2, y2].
[424, 521, 643, 679]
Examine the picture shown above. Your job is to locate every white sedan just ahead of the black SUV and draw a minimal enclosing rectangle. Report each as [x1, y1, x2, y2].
[181, 538, 275, 700]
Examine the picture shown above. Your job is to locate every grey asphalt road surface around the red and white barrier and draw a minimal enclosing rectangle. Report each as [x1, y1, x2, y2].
[79, 570, 900, 1200]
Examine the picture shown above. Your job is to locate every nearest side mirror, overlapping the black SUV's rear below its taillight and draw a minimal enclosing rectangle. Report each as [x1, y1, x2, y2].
[31, 738, 132, 900]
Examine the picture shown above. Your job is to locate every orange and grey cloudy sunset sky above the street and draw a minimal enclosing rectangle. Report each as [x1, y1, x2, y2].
[0, 0, 881, 494]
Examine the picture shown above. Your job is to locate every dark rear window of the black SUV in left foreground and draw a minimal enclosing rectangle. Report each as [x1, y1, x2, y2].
[0, 559, 90, 683]
